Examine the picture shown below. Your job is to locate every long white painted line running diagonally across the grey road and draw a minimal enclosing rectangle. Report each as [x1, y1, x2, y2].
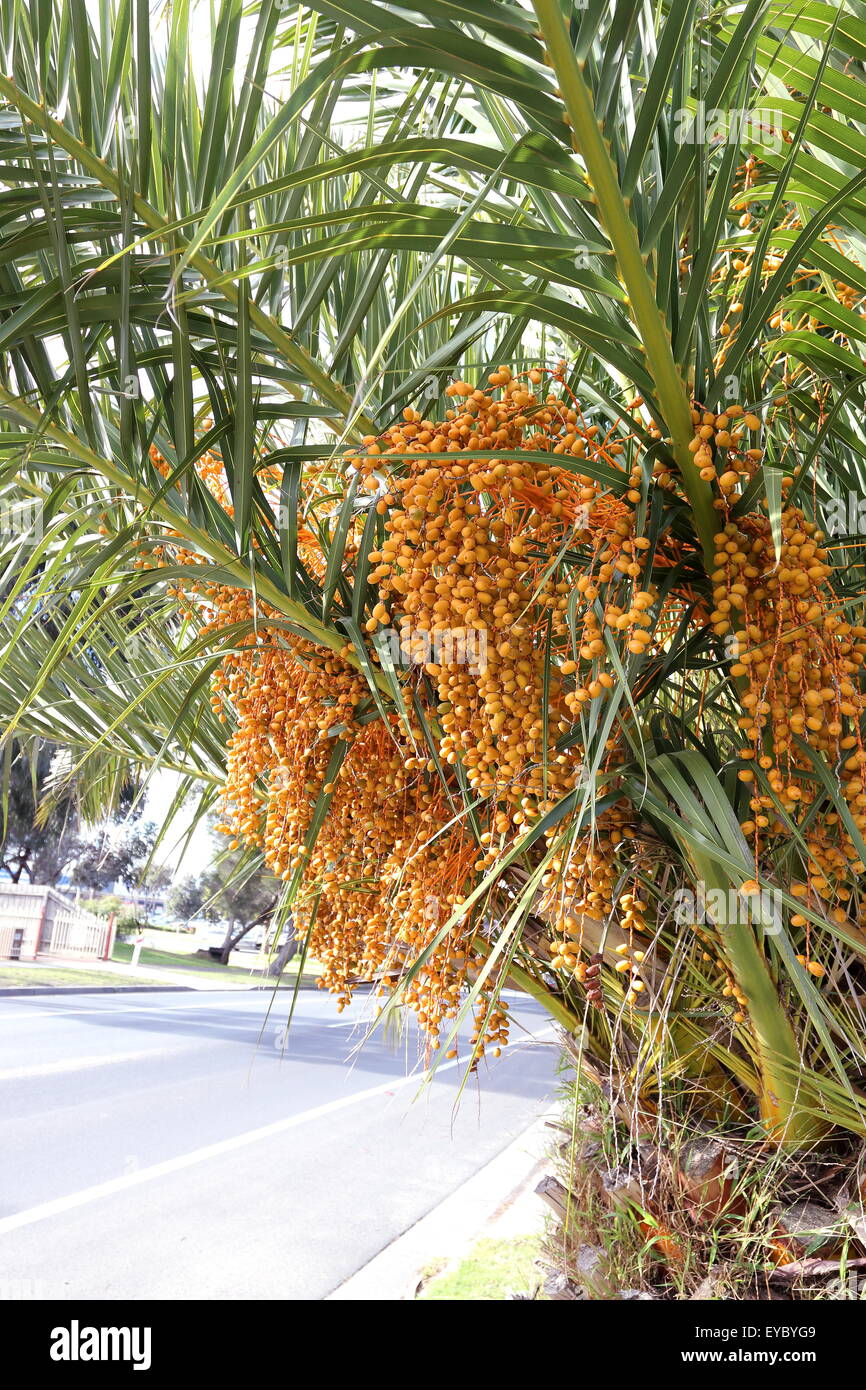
[0, 1027, 555, 1236]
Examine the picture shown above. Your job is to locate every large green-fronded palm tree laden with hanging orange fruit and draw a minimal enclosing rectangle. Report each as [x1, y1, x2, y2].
[0, 0, 866, 1278]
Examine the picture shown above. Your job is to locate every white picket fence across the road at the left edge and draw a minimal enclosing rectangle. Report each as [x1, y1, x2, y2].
[0, 883, 111, 960]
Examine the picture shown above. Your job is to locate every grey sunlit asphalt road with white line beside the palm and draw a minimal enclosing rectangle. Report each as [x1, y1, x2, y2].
[0, 991, 557, 1300]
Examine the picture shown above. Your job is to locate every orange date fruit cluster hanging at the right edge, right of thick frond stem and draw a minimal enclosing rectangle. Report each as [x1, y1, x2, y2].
[712, 506, 866, 945]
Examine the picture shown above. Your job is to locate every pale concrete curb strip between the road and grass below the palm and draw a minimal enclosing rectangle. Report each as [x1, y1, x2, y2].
[325, 1109, 557, 1302]
